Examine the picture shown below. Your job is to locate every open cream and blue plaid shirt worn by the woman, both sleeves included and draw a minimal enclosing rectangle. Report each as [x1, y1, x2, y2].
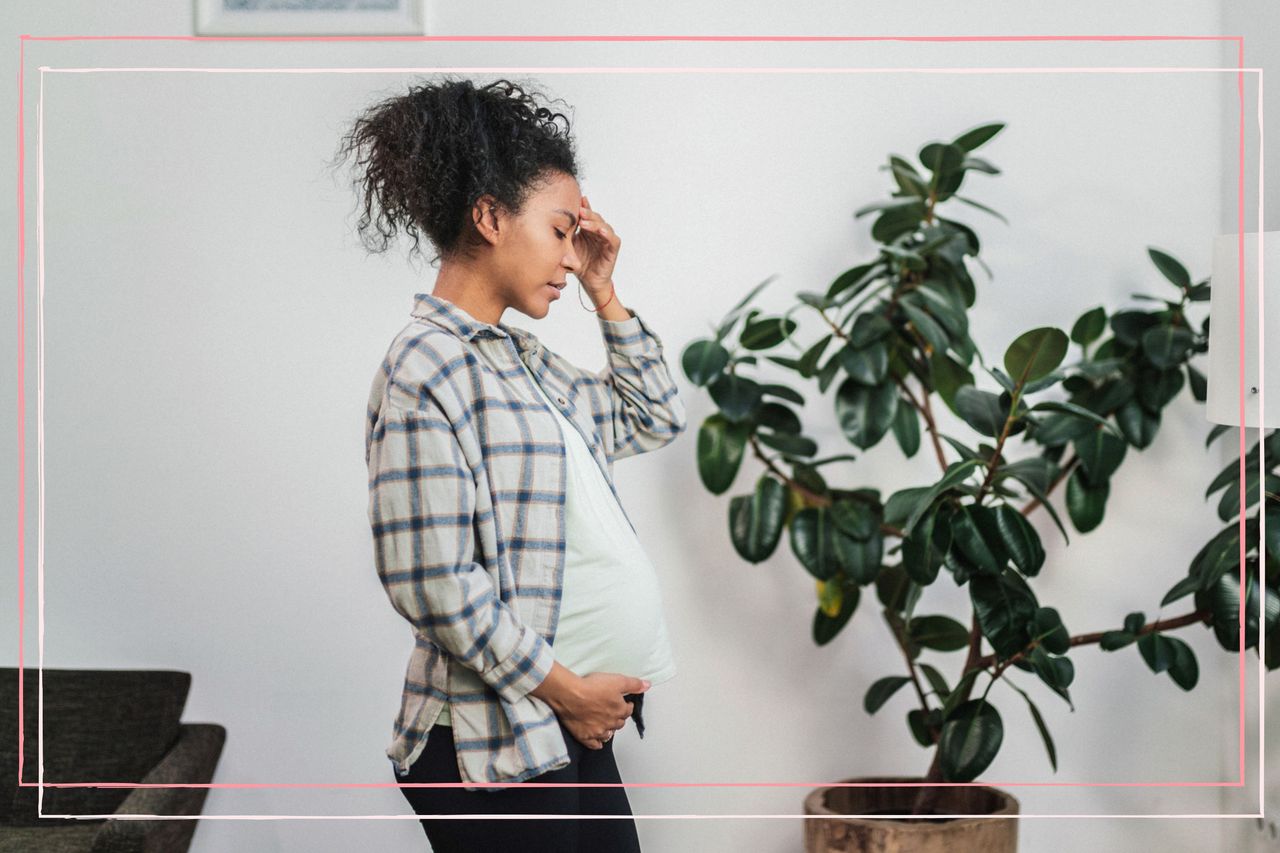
[365, 293, 686, 790]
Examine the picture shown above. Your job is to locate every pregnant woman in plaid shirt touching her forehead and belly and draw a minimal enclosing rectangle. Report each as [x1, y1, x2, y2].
[339, 81, 686, 853]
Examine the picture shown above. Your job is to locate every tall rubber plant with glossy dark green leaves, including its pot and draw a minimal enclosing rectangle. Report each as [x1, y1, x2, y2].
[681, 123, 1280, 853]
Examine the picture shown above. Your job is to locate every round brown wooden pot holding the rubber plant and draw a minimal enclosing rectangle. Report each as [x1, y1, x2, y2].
[804, 776, 1018, 853]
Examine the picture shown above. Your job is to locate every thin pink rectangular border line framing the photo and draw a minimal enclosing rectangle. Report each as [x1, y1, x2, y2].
[18, 33, 1265, 820]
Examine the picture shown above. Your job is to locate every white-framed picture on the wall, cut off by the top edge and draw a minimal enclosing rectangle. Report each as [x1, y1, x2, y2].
[196, 0, 426, 36]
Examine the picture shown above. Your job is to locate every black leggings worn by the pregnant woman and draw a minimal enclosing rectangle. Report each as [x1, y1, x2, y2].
[396, 695, 640, 853]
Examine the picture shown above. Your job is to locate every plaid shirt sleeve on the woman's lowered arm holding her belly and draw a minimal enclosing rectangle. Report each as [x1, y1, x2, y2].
[367, 397, 554, 702]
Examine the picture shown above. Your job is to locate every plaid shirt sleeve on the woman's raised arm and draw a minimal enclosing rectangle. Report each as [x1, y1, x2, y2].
[595, 309, 687, 461]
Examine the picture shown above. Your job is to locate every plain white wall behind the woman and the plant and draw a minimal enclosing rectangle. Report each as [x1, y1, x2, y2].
[0, 0, 1264, 853]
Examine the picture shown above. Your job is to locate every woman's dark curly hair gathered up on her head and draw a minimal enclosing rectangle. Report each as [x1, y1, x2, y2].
[333, 78, 579, 264]
